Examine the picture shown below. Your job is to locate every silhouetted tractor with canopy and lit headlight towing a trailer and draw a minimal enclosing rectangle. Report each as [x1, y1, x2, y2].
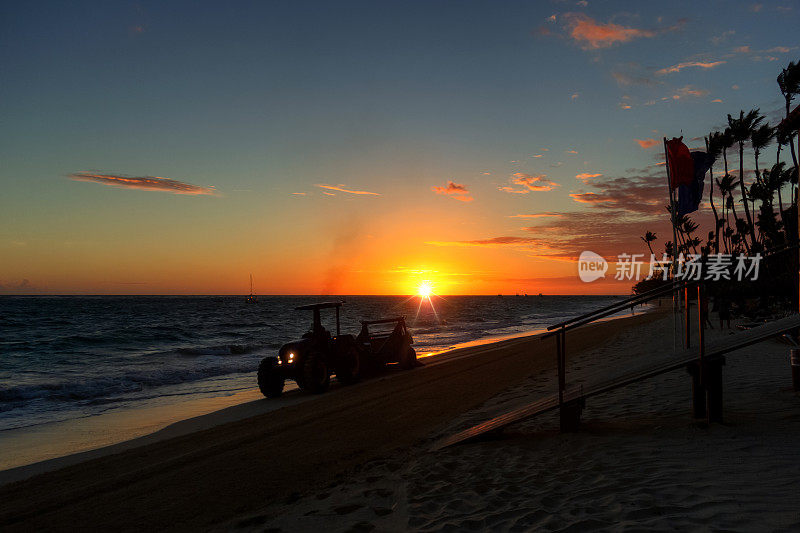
[258, 302, 417, 398]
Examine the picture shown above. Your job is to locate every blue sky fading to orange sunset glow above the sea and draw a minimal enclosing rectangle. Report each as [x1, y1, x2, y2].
[0, 0, 800, 292]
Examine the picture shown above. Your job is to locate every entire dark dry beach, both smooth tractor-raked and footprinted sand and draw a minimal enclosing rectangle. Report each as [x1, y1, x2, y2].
[0, 306, 800, 531]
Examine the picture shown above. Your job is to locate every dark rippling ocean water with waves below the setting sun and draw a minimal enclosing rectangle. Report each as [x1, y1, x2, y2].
[0, 296, 619, 435]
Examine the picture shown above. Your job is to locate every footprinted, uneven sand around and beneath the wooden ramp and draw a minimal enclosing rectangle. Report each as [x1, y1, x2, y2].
[227, 317, 800, 531]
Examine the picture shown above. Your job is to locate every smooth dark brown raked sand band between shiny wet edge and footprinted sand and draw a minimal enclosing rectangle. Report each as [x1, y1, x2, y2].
[0, 313, 659, 531]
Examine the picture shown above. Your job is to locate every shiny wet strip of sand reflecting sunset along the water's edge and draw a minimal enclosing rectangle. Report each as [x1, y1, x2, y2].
[0, 306, 657, 480]
